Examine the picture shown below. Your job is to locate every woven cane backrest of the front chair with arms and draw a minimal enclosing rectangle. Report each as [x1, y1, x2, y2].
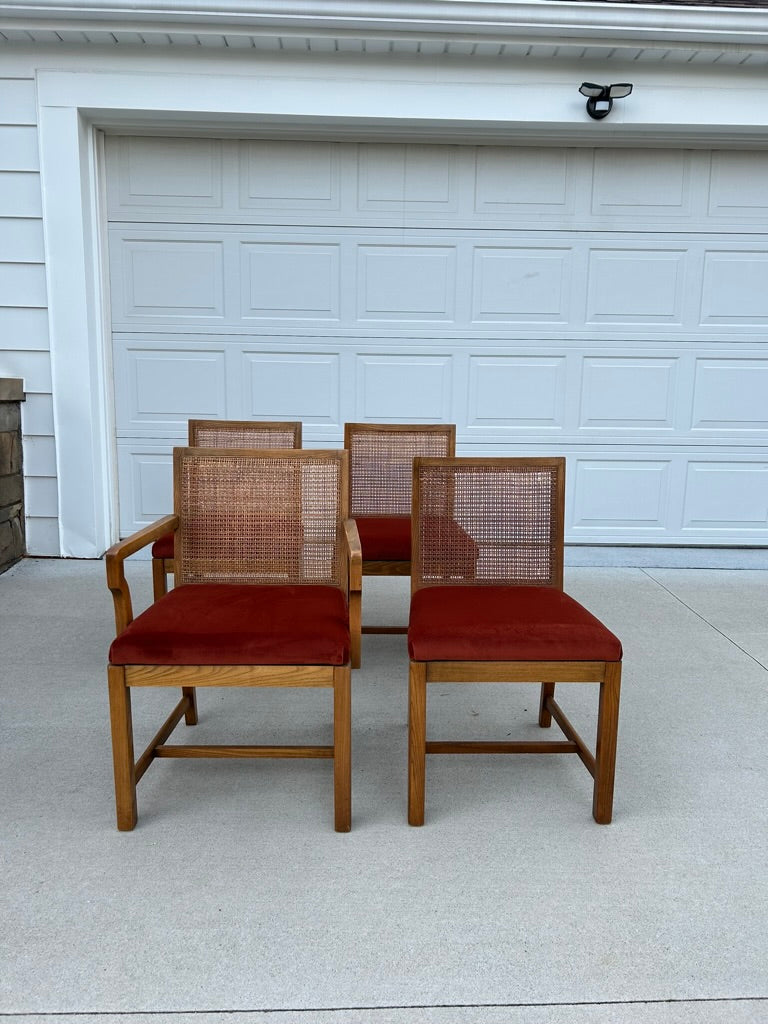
[174, 449, 346, 588]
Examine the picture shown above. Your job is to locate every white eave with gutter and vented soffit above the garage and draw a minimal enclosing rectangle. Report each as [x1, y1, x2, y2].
[0, 0, 768, 66]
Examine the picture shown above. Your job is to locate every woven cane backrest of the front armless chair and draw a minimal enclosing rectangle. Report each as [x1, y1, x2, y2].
[411, 459, 564, 589]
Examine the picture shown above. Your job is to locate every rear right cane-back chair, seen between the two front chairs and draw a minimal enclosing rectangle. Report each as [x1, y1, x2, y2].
[344, 423, 456, 633]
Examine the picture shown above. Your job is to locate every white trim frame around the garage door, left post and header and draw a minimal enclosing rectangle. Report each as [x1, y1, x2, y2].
[37, 59, 768, 558]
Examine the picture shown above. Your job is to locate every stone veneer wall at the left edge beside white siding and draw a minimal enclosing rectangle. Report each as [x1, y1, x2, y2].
[0, 377, 26, 572]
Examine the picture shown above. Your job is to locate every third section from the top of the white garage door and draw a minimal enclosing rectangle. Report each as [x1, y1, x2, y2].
[115, 334, 768, 444]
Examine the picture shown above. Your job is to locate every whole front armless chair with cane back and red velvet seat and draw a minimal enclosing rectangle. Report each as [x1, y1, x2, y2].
[408, 458, 622, 825]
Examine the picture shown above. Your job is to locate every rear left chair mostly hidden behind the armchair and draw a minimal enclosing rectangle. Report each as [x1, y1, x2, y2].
[152, 420, 301, 599]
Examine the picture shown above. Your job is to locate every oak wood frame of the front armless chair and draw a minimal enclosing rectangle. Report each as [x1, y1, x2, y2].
[408, 458, 622, 825]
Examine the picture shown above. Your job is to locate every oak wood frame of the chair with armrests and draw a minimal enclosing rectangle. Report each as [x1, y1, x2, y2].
[105, 450, 362, 831]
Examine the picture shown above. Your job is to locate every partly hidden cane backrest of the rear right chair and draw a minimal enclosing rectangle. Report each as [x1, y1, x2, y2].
[346, 425, 455, 517]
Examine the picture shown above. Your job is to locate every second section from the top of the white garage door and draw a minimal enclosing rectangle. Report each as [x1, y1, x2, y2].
[110, 225, 768, 340]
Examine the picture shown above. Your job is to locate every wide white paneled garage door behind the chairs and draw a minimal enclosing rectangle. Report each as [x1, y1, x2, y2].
[106, 137, 768, 545]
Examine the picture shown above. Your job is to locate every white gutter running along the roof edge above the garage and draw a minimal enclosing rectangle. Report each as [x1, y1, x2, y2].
[0, 0, 768, 45]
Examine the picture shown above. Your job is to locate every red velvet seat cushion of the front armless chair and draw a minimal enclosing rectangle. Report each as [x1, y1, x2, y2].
[408, 586, 622, 662]
